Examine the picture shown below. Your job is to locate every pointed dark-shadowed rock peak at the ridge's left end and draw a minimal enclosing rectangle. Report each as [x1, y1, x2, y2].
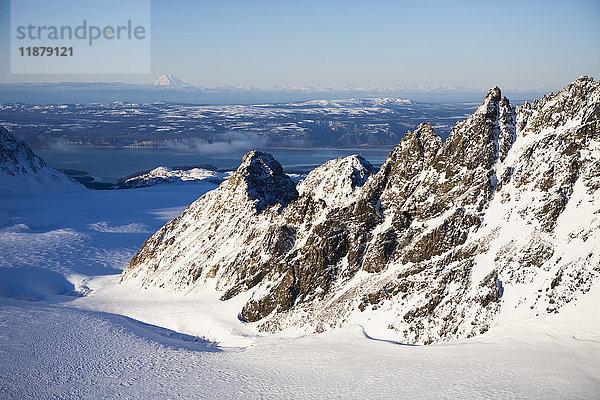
[224, 150, 298, 211]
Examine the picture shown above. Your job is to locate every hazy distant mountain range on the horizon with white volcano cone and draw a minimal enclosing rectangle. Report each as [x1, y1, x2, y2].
[0, 74, 548, 104]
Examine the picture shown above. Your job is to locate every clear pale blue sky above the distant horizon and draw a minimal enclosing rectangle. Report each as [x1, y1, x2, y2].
[0, 0, 600, 89]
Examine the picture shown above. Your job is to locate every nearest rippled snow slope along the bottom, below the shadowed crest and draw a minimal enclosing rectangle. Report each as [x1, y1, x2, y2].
[0, 299, 600, 399]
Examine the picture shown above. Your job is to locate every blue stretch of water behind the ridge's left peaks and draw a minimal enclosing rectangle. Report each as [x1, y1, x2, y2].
[34, 148, 391, 183]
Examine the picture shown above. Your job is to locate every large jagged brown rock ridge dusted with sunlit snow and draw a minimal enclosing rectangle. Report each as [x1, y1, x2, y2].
[122, 77, 600, 344]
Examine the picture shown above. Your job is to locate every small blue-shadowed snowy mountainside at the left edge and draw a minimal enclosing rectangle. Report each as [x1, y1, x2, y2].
[0, 126, 85, 194]
